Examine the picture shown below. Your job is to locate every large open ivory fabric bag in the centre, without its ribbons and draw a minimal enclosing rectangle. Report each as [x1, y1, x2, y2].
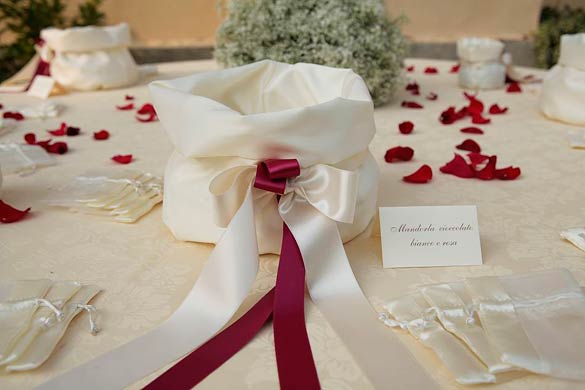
[150, 60, 378, 253]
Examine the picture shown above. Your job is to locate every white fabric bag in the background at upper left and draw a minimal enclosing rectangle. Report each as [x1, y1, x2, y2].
[40, 23, 139, 91]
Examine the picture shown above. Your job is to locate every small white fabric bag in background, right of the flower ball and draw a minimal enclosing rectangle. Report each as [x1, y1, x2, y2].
[457, 37, 506, 89]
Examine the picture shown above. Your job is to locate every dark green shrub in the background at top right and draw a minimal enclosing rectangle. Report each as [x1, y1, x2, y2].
[534, 7, 585, 68]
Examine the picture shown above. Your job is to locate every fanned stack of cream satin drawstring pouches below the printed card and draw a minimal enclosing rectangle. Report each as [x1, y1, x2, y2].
[381, 269, 585, 384]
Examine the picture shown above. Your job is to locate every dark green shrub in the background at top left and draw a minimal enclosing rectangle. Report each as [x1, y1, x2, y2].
[0, 0, 104, 80]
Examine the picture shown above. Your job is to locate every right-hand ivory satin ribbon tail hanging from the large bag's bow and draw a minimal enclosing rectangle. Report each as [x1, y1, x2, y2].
[279, 200, 438, 390]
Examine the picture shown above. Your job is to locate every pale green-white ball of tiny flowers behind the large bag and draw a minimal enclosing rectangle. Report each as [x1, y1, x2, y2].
[215, 0, 407, 104]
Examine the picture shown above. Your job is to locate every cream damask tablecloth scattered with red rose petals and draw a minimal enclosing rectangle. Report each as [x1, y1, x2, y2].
[0, 60, 585, 390]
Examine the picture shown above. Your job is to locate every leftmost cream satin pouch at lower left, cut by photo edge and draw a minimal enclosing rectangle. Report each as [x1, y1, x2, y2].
[0, 279, 51, 359]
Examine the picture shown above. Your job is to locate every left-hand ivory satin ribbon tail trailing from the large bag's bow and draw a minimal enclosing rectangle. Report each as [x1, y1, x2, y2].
[38, 188, 258, 390]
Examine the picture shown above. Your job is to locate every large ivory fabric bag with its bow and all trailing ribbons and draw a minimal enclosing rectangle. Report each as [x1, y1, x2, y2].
[41, 61, 436, 389]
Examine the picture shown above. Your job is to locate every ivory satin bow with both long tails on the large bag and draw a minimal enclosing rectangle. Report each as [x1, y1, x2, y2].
[40, 164, 437, 390]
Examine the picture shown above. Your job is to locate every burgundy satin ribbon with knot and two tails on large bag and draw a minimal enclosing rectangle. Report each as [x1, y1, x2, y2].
[145, 159, 321, 390]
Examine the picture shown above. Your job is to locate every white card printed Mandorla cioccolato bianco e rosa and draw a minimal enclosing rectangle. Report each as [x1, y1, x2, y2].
[380, 206, 482, 268]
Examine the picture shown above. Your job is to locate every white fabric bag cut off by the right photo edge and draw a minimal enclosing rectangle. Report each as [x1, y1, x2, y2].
[540, 33, 585, 125]
